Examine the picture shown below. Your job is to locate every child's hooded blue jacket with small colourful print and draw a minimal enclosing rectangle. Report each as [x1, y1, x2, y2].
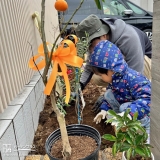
[89, 40, 151, 119]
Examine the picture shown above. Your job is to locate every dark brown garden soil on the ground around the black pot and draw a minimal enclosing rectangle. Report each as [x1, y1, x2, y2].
[30, 82, 121, 160]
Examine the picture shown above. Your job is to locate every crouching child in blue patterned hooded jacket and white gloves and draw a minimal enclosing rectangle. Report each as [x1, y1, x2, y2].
[89, 40, 151, 136]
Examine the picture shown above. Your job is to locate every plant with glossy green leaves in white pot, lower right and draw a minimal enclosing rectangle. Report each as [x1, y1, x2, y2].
[102, 109, 154, 160]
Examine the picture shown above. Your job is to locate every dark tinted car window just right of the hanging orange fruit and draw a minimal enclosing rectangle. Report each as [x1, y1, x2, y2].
[66, 0, 99, 15]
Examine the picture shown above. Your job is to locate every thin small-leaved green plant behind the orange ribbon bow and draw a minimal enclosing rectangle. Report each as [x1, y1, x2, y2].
[56, 33, 89, 121]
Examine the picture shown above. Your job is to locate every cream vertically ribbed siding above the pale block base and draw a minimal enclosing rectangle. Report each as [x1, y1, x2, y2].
[0, 0, 59, 113]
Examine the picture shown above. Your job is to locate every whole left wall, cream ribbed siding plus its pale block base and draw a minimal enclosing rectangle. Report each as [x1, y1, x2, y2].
[0, 0, 59, 160]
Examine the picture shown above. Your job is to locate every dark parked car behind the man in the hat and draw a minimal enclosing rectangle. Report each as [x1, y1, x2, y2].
[59, 0, 153, 41]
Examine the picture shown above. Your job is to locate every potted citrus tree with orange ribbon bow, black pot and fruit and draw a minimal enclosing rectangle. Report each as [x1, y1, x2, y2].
[29, 0, 101, 160]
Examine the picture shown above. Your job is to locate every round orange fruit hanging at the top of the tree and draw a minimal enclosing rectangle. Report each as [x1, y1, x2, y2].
[54, 0, 68, 11]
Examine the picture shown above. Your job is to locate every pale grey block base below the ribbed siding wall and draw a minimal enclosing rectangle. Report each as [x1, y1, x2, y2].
[0, 73, 45, 160]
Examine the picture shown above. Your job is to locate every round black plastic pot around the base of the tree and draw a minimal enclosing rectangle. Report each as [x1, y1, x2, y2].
[45, 124, 101, 160]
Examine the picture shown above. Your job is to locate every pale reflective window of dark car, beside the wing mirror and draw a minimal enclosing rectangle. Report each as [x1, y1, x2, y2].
[103, 0, 126, 16]
